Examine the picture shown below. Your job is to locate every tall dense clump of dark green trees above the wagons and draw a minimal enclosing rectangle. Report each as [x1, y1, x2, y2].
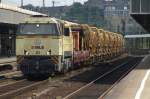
[64, 3, 104, 26]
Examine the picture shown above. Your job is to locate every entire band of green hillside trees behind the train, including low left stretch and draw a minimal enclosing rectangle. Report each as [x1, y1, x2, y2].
[23, 2, 106, 27]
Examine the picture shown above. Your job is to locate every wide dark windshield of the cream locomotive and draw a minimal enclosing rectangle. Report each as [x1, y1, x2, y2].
[18, 23, 60, 35]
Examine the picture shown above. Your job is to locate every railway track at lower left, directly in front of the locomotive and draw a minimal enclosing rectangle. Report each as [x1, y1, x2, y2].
[0, 79, 48, 99]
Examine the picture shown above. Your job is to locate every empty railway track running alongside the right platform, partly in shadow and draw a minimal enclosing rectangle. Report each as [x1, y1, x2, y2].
[63, 58, 140, 99]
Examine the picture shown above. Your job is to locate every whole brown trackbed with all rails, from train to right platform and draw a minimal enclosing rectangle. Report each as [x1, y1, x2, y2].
[0, 58, 140, 99]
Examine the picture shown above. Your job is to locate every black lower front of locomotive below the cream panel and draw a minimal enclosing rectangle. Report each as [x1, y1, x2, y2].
[20, 56, 59, 74]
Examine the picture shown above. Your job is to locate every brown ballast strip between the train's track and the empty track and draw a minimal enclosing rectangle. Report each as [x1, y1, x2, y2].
[14, 67, 96, 99]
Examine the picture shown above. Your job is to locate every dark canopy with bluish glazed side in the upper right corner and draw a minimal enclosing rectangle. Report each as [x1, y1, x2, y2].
[130, 0, 150, 32]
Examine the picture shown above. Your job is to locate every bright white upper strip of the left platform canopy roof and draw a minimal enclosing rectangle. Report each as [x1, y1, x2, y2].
[0, 3, 46, 16]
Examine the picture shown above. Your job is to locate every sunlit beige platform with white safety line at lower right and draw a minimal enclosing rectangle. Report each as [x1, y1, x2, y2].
[103, 55, 150, 99]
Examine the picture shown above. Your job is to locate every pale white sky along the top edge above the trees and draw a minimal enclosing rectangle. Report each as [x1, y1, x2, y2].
[2, 0, 88, 6]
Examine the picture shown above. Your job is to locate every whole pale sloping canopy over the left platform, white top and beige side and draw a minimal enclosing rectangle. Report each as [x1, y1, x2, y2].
[0, 3, 47, 25]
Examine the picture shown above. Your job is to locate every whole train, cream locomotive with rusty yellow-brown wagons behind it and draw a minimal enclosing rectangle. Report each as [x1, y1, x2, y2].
[16, 16, 124, 77]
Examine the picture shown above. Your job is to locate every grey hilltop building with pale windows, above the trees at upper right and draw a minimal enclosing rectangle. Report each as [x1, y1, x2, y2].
[85, 0, 130, 16]
